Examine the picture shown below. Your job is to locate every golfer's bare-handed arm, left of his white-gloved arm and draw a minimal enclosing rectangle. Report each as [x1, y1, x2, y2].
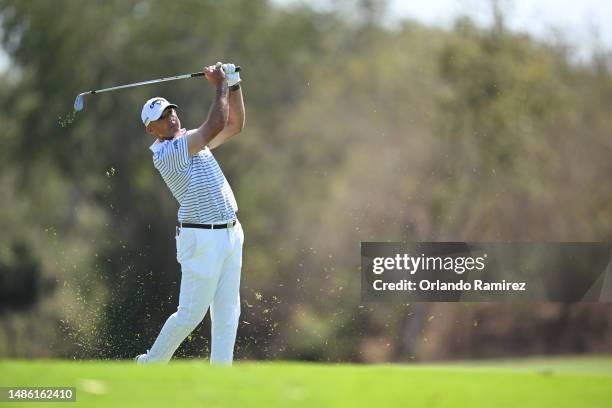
[187, 64, 229, 156]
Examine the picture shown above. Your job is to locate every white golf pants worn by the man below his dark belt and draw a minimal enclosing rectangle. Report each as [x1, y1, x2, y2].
[145, 221, 244, 364]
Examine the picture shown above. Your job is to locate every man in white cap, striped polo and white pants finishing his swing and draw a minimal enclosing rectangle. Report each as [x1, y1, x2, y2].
[135, 62, 244, 365]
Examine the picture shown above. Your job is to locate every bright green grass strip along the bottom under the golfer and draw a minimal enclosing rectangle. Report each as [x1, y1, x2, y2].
[0, 356, 612, 408]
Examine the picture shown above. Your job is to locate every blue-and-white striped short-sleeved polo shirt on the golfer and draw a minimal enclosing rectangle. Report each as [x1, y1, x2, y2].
[150, 130, 238, 224]
